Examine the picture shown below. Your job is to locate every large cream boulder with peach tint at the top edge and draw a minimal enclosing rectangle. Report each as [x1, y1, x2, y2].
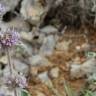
[20, 0, 45, 25]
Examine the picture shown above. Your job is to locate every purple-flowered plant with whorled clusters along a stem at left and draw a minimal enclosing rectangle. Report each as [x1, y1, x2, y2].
[0, 4, 27, 96]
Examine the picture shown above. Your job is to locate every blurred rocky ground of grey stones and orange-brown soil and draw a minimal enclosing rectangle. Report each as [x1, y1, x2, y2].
[0, 0, 96, 96]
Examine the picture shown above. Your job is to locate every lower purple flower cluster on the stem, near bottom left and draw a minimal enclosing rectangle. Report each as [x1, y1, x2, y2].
[5, 74, 27, 88]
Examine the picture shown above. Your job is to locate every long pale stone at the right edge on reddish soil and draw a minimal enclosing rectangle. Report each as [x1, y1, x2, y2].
[70, 58, 96, 78]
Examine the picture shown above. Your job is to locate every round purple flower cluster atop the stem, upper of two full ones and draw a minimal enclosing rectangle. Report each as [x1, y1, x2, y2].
[0, 29, 20, 48]
